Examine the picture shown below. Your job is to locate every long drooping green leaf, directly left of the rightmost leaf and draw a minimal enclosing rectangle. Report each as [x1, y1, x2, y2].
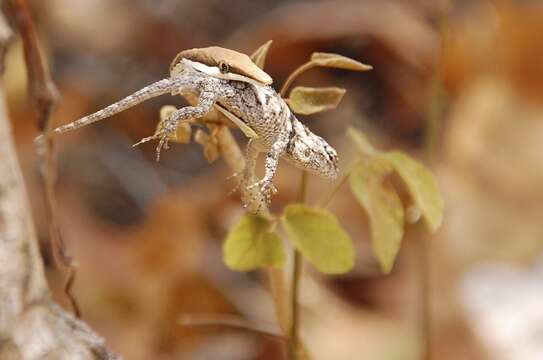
[349, 157, 404, 273]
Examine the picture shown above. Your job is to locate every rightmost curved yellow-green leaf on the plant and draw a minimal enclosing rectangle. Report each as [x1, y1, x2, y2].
[380, 151, 444, 232]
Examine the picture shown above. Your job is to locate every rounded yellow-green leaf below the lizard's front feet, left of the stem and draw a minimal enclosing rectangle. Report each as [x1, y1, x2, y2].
[223, 214, 286, 271]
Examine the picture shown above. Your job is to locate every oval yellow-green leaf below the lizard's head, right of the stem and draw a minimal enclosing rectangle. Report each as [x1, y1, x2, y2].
[281, 204, 355, 274]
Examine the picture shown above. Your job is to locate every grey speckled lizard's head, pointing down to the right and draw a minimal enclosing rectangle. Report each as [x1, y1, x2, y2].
[286, 121, 338, 179]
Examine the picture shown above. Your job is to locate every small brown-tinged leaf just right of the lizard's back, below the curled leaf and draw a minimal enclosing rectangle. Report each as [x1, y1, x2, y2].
[287, 86, 346, 115]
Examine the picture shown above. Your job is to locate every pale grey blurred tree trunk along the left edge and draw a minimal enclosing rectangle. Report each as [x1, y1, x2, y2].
[0, 5, 120, 360]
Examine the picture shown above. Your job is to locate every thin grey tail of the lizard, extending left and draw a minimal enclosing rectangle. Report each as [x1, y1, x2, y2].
[52, 79, 176, 134]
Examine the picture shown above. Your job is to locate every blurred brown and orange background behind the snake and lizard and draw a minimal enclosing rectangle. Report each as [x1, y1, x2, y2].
[5, 0, 543, 360]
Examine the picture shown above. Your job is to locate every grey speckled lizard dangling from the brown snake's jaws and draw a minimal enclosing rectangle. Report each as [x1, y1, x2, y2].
[49, 61, 338, 207]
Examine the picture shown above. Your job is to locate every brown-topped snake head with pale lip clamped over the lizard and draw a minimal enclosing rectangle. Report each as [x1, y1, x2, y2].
[170, 46, 273, 85]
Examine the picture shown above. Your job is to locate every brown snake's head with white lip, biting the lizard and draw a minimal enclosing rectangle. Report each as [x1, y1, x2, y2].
[170, 46, 273, 85]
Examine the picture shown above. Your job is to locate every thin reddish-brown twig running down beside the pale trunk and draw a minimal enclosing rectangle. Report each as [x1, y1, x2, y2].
[7, 0, 81, 317]
